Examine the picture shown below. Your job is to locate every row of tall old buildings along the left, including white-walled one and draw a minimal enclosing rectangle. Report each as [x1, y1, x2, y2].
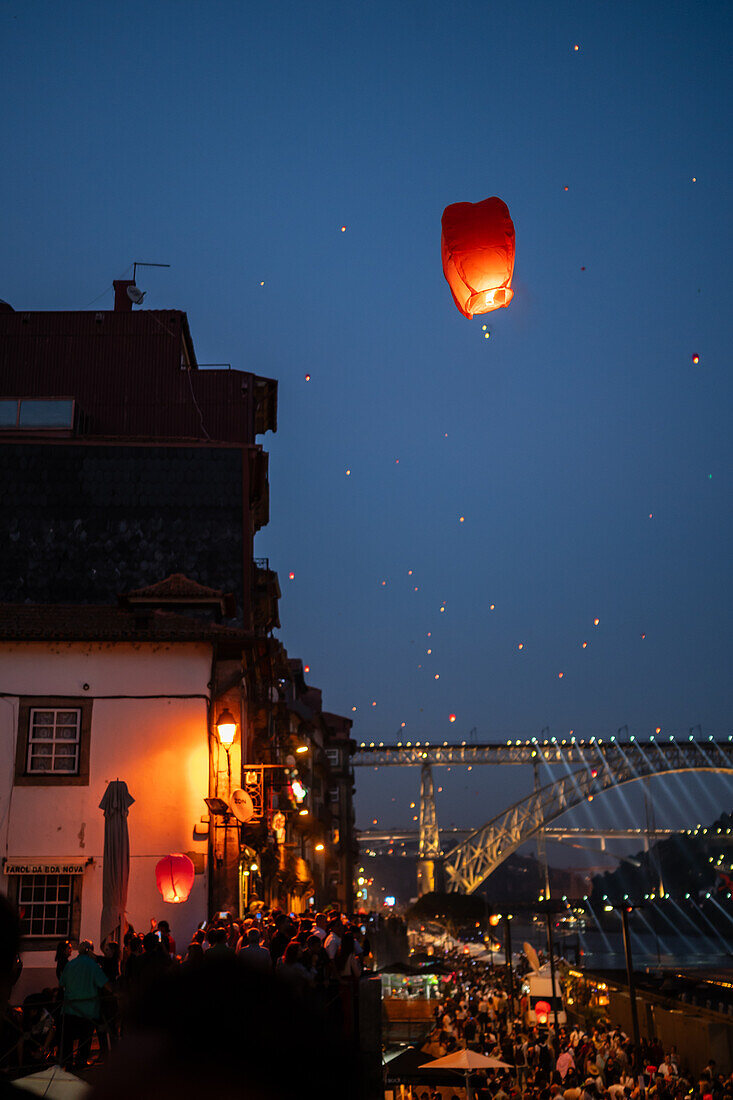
[0, 281, 353, 961]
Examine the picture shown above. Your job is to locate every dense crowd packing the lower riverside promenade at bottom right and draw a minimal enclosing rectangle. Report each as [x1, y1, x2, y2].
[407, 956, 733, 1100]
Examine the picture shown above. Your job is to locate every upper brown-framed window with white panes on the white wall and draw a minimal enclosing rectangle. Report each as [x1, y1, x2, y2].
[15, 696, 91, 787]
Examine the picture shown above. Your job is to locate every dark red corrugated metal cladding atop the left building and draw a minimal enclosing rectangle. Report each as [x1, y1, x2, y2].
[0, 310, 277, 444]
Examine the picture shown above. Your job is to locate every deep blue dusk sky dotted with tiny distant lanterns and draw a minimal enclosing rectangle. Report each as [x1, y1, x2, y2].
[0, 0, 733, 849]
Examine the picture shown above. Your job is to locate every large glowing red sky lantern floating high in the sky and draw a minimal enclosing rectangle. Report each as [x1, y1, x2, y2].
[440, 196, 514, 319]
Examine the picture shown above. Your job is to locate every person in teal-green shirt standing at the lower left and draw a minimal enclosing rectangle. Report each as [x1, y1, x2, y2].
[59, 939, 112, 1069]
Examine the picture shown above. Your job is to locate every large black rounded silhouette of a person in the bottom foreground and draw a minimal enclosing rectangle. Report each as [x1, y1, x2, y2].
[91, 952, 345, 1100]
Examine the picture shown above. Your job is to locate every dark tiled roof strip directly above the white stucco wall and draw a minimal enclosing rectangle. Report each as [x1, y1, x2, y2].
[0, 604, 253, 646]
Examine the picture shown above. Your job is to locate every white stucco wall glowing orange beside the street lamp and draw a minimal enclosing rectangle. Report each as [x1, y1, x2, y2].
[0, 642, 211, 992]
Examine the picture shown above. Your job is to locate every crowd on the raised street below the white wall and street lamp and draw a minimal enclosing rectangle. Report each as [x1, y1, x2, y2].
[4, 910, 372, 1070]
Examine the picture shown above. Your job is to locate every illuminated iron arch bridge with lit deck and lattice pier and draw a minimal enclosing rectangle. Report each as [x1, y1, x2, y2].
[353, 734, 733, 893]
